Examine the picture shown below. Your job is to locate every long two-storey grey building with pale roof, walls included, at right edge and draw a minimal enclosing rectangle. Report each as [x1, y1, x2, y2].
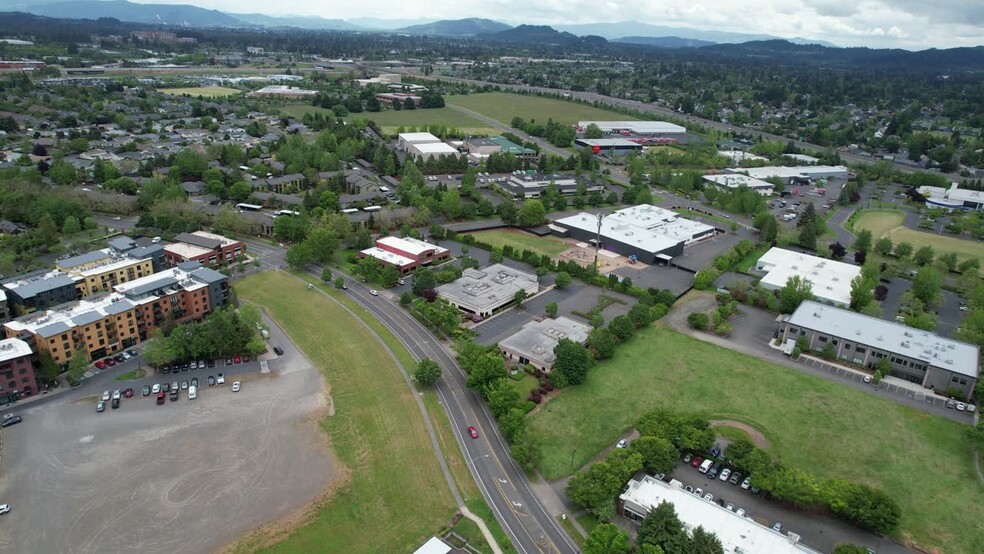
[781, 301, 980, 399]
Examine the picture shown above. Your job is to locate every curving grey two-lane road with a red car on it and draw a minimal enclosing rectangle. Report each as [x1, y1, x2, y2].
[309, 260, 578, 554]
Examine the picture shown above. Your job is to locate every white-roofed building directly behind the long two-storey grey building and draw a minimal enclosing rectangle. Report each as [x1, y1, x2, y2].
[755, 248, 861, 306]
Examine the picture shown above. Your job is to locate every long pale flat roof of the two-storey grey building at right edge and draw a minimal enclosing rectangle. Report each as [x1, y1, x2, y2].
[789, 301, 980, 379]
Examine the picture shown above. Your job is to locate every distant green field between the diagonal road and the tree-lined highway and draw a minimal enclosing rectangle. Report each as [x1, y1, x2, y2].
[445, 92, 636, 125]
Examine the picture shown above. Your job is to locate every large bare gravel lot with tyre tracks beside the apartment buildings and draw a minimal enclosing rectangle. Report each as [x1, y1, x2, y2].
[0, 314, 336, 553]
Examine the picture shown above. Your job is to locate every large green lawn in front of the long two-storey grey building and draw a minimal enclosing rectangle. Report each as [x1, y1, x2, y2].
[532, 325, 984, 554]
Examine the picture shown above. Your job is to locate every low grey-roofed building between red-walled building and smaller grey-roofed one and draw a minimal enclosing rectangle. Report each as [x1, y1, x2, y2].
[437, 264, 540, 317]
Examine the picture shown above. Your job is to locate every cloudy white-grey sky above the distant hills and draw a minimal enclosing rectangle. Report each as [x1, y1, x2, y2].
[134, 0, 984, 50]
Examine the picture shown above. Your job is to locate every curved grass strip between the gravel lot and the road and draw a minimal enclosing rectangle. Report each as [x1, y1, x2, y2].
[236, 271, 456, 553]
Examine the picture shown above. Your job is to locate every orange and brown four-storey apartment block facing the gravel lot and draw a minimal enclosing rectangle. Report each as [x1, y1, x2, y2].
[4, 263, 229, 366]
